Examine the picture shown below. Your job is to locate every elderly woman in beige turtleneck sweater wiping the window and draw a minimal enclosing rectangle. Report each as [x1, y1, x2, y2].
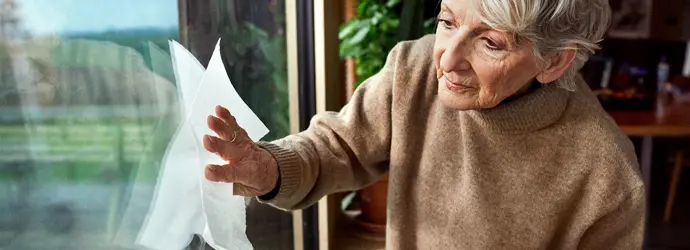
[204, 0, 645, 249]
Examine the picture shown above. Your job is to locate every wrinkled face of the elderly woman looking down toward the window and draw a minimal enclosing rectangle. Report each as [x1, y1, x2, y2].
[434, 0, 540, 110]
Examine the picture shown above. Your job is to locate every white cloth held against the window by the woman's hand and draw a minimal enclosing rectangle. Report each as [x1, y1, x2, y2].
[137, 40, 268, 250]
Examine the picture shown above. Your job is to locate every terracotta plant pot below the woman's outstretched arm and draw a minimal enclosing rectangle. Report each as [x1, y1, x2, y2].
[355, 174, 388, 234]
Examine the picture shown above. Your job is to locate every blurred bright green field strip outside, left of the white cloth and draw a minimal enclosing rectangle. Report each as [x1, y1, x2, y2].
[0, 117, 170, 182]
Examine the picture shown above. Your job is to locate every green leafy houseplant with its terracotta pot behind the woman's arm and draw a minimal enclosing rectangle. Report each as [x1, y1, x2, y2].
[338, 0, 434, 234]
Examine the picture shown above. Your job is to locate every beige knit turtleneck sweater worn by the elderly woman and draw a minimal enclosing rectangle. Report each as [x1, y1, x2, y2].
[255, 36, 645, 250]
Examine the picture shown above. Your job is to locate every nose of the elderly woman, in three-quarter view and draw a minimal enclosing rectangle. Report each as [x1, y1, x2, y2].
[441, 27, 471, 72]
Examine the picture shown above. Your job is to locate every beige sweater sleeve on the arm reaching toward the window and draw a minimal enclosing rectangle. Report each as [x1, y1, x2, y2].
[253, 45, 400, 210]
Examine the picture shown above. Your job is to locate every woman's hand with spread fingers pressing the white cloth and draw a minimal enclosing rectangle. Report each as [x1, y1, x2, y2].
[204, 106, 278, 196]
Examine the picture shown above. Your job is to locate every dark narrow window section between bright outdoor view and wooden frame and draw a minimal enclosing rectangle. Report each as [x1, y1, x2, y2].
[182, 0, 293, 249]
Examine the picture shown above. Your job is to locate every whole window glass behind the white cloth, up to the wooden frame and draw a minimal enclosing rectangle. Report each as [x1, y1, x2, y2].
[0, 0, 292, 249]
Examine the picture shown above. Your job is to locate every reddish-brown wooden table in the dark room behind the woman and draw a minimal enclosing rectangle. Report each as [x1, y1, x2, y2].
[609, 104, 690, 246]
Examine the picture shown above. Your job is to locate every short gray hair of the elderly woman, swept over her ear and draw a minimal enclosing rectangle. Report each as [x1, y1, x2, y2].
[473, 0, 611, 91]
